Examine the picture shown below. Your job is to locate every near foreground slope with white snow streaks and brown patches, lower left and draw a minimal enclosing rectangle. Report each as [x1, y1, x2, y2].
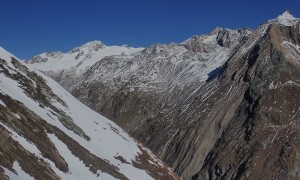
[0, 48, 176, 179]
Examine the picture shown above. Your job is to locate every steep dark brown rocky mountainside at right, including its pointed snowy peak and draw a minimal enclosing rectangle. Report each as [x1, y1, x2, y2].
[194, 12, 300, 179]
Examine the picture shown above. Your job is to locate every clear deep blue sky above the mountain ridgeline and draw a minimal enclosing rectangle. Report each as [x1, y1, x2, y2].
[0, 0, 300, 59]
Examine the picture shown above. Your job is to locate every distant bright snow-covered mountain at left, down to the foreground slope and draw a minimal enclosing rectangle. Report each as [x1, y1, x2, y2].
[26, 41, 143, 90]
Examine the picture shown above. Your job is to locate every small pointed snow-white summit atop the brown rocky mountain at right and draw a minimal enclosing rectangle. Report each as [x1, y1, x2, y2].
[268, 10, 299, 26]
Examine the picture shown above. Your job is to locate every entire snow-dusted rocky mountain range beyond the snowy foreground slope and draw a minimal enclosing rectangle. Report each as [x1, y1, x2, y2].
[28, 11, 300, 180]
